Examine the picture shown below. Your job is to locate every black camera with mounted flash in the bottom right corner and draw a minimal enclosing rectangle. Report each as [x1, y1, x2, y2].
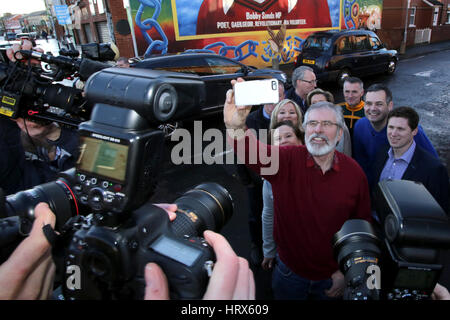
[333, 180, 450, 300]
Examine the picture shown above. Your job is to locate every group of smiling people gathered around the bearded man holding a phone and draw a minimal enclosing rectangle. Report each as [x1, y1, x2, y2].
[224, 66, 449, 300]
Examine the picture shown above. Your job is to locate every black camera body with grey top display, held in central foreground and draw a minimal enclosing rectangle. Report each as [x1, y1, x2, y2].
[63, 200, 215, 299]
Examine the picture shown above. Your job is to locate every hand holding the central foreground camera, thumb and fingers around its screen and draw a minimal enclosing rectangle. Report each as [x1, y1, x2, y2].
[144, 230, 255, 300]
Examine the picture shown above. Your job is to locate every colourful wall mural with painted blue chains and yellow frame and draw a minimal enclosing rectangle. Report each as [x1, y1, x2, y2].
[130, 0, 382, 66]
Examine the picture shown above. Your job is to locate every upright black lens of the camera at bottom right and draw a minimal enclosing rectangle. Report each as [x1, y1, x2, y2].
[333, 219, 381, 300]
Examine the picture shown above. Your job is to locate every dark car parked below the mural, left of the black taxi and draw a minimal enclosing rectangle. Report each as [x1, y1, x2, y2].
[131, 53, 287, 115]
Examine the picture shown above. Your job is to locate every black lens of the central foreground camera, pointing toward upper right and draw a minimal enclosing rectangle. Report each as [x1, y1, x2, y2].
[172, 183, 233, 236]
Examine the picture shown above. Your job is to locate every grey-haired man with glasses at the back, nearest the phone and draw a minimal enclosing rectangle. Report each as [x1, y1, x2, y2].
[285, 66, 317, 115]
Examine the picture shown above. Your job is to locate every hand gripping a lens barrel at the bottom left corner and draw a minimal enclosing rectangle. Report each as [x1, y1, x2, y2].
[0, 203, 56, 300]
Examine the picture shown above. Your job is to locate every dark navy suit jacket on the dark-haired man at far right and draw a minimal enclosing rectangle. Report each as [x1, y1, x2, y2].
[371, 145, 450, 215]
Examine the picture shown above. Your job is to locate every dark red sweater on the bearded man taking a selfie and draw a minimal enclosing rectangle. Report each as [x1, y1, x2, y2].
[229, 131, 371, 280]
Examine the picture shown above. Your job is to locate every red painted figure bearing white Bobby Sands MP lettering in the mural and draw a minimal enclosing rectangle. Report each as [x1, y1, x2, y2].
[196, 0, 332, 35]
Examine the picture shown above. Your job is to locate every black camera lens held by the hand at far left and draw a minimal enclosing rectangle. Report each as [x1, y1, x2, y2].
[1, 180, 77, 232]
